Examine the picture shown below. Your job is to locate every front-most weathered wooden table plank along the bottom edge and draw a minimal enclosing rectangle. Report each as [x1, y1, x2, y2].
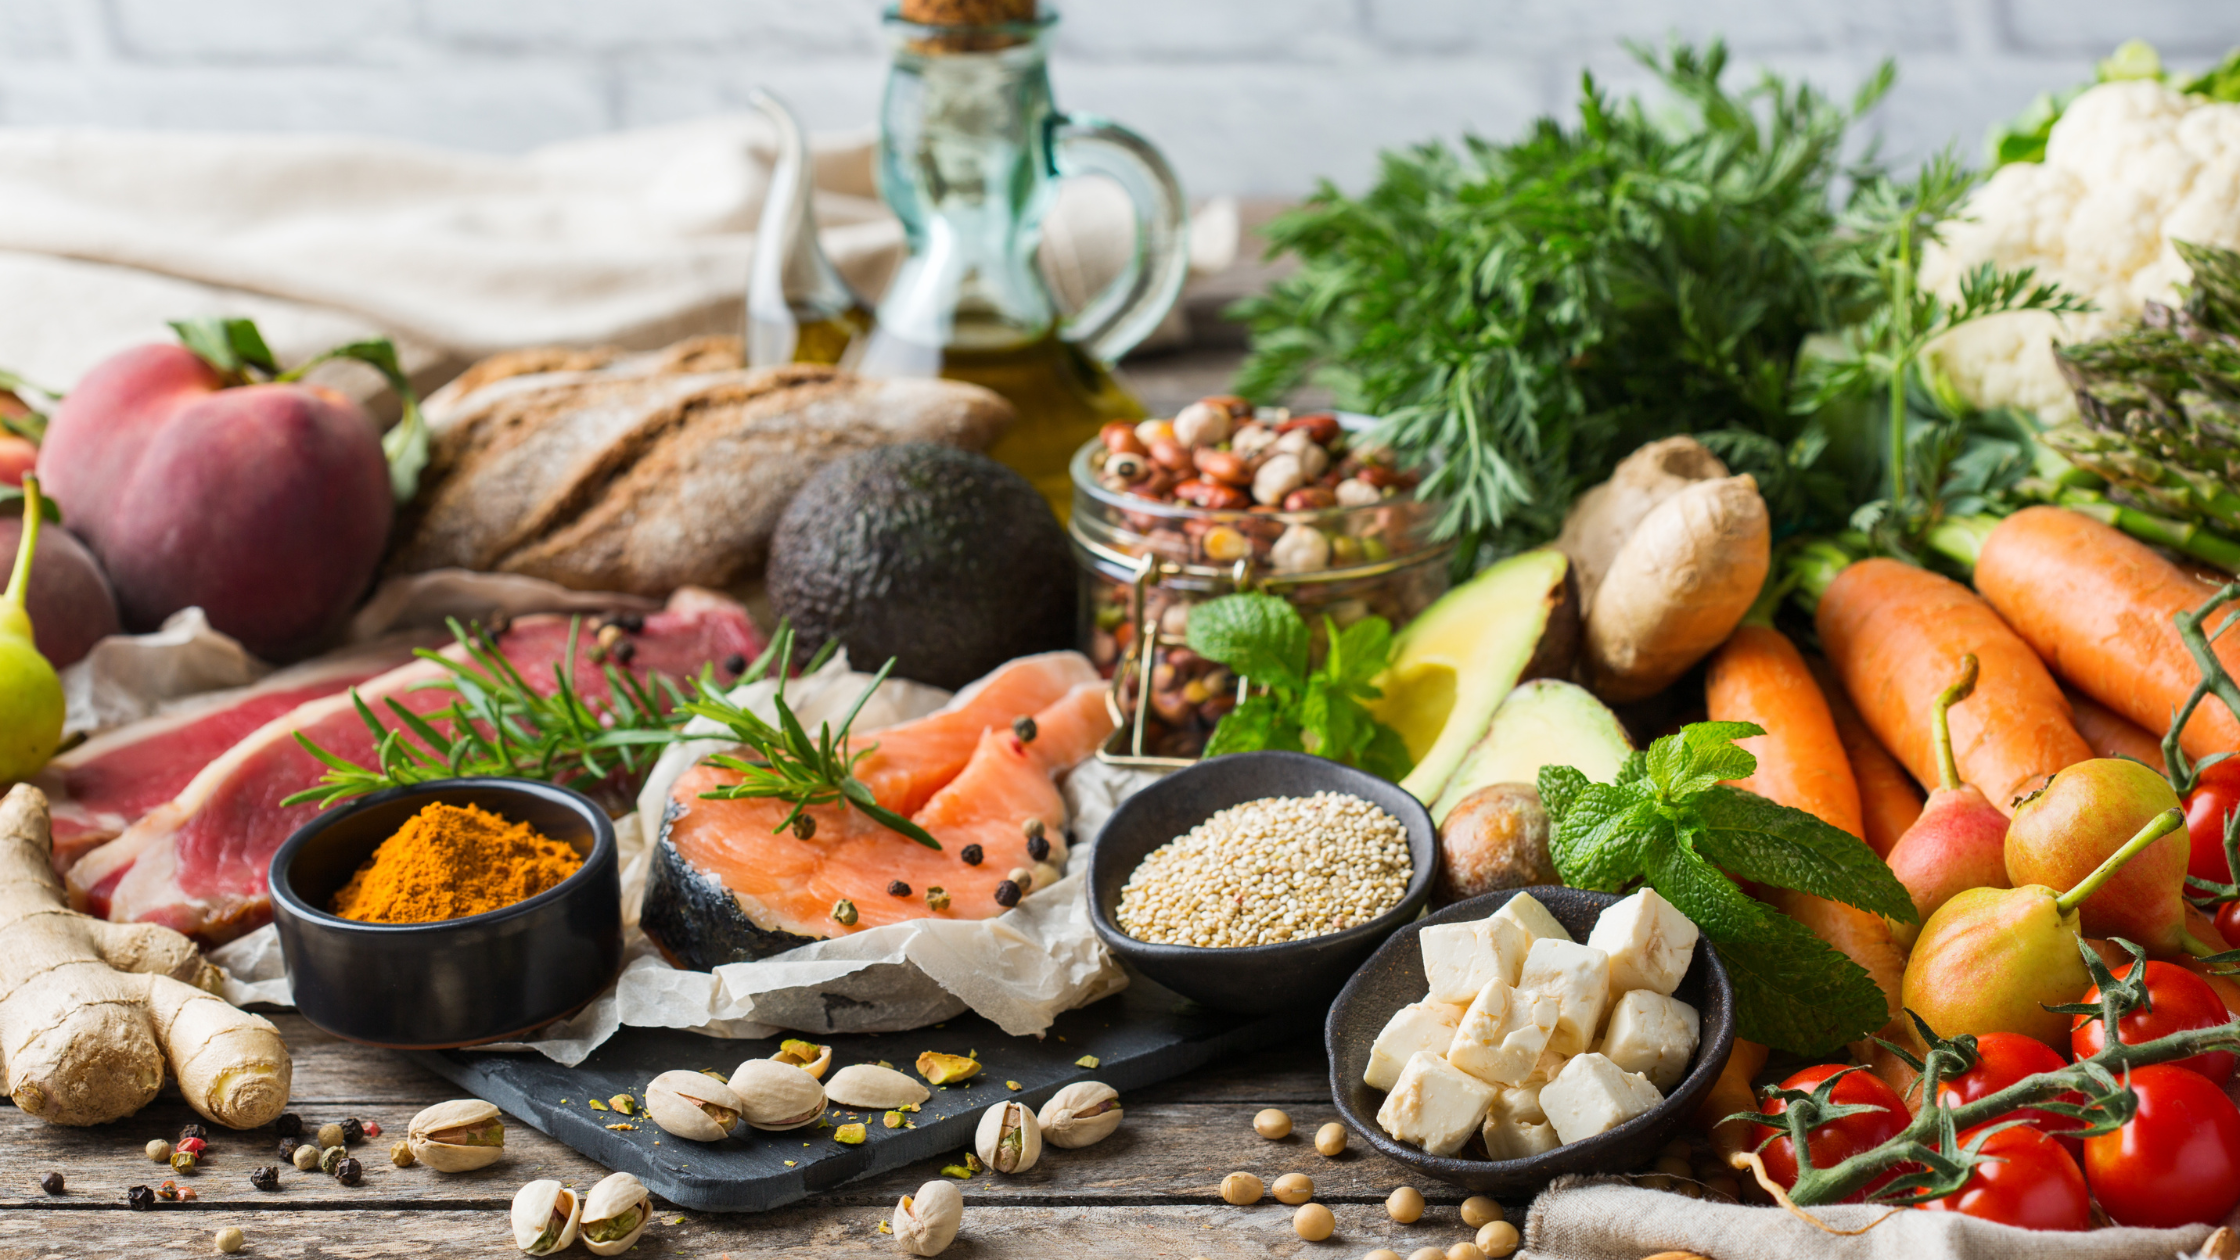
[0, 1193, 1523, 1260]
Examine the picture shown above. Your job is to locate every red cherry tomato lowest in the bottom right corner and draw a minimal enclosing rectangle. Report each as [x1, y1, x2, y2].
[2085, 1063, 2240, 1229]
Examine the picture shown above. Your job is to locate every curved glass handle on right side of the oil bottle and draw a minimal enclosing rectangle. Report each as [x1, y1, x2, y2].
[1051, 114, 1189, 363]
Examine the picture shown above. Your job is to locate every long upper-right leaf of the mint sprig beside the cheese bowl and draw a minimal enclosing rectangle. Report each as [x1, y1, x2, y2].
[1693, 787, 1917, 924]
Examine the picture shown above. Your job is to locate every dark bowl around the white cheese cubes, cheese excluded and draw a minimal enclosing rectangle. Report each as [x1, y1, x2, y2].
[1322, 888, 1734, 1197]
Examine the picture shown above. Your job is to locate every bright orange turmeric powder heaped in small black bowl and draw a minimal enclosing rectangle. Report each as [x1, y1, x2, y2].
[332, 800, 582, 924]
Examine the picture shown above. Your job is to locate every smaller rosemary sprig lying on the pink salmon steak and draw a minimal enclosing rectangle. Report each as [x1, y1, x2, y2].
[683, 626, 941, 850]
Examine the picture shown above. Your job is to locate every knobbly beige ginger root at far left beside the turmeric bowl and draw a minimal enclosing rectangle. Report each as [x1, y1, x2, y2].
[0, 785, 291, 1128]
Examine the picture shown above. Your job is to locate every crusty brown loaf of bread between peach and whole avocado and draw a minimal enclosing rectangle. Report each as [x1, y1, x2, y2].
[390, 336, 1012, 596]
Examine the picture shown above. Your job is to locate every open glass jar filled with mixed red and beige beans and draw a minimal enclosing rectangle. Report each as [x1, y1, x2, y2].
[1068, 397, 1454, 767]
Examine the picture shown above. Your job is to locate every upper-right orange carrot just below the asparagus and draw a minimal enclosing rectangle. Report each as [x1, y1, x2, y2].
[1976, 507, 2240, 762]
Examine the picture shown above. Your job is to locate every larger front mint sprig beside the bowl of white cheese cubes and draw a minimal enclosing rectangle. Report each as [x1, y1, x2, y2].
[1539, 722, 1915, 1054]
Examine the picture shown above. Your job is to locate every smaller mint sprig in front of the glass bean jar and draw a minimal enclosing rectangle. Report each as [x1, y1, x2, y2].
[1187, 594, 1411, 780]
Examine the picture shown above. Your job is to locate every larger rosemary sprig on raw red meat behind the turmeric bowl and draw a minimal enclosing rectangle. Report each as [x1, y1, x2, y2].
[280, 617, 685, 807]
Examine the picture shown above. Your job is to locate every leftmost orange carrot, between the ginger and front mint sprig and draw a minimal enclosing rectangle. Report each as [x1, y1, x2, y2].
[1702, 623, 1866, 836]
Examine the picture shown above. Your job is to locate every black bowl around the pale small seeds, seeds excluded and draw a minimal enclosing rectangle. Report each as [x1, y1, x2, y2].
[1089, 753, 1438, 1016]
